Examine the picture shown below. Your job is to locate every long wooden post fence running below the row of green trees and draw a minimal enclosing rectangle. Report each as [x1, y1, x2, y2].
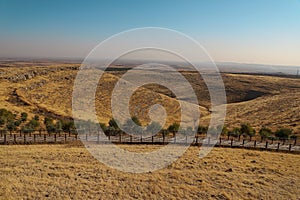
[0, 130, 300, 153]
